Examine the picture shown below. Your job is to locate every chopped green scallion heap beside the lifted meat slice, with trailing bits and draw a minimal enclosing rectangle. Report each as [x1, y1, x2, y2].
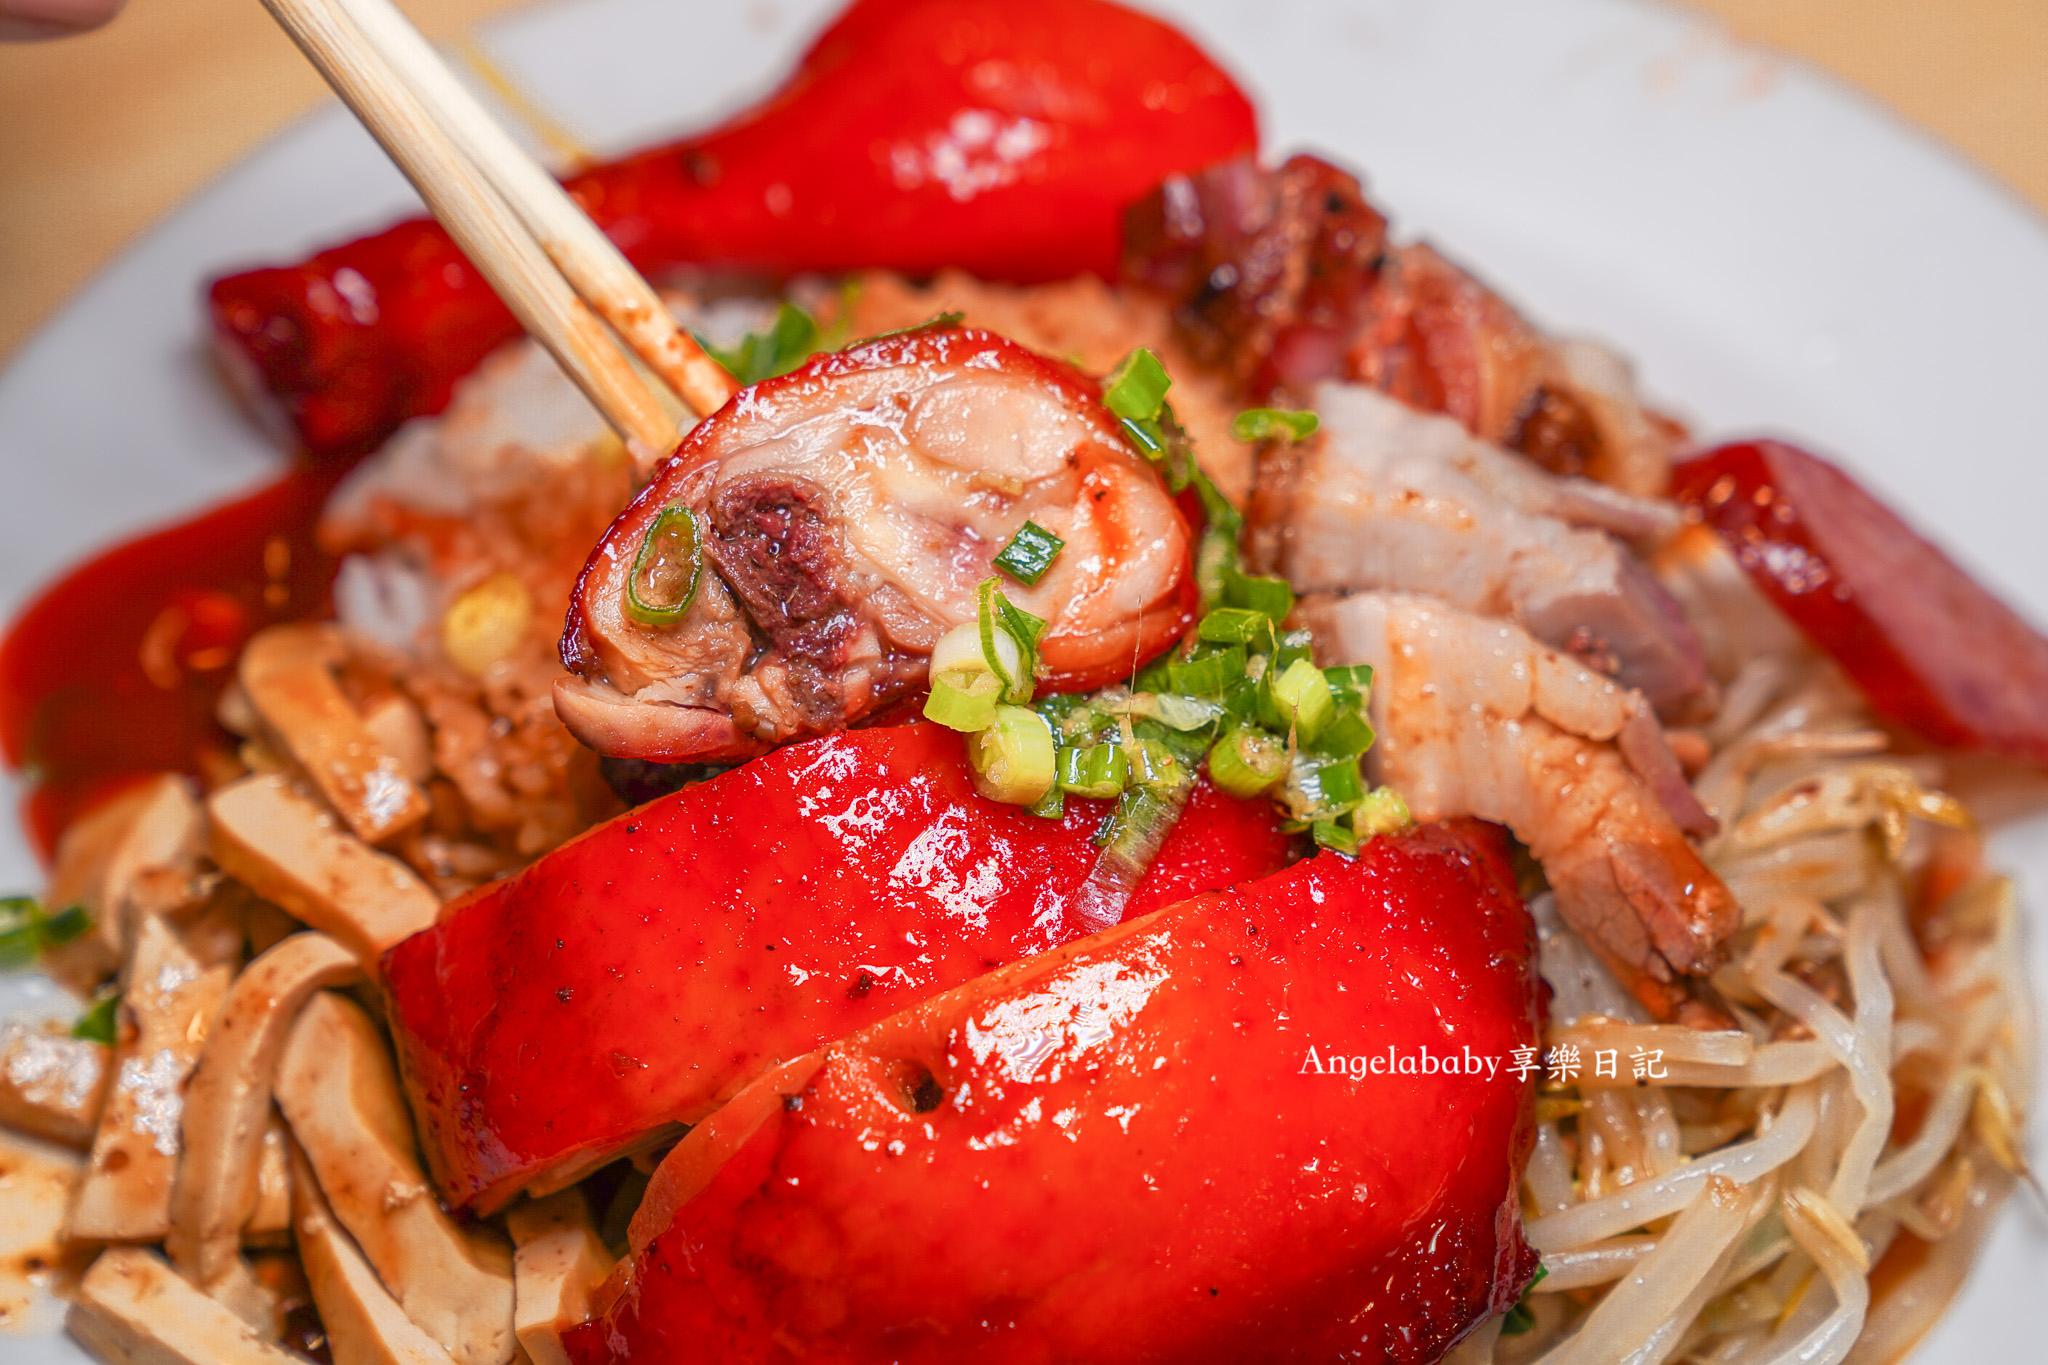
[926, 350, 1409, 871]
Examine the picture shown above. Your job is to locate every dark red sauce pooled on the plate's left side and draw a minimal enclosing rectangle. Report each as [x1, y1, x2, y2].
[0, 467, 342, 857]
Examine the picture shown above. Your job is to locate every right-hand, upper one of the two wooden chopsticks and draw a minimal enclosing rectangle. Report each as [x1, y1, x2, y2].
[334, 0, 739, 417]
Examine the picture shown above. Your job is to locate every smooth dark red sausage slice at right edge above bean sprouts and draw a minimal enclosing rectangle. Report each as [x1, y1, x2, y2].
[1673, 440, 2048, 763]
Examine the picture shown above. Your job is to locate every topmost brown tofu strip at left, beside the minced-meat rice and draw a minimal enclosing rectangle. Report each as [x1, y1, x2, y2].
[236, 622, 426, 843]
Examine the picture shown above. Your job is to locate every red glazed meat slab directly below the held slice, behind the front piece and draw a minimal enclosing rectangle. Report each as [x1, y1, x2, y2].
[383, 724, 1288, 1212]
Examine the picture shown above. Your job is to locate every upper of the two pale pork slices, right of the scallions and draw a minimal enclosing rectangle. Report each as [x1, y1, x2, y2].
[1251, 385, 1706, 714]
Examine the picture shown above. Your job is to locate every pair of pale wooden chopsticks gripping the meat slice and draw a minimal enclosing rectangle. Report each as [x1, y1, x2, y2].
[264, 0, 737, 473]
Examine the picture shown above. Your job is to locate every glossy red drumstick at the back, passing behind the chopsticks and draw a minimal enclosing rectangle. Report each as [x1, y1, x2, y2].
[211, 0, 1257, 458]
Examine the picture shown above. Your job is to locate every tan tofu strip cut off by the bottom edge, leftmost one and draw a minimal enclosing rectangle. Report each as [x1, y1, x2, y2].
[66, 1246, 303, 1365]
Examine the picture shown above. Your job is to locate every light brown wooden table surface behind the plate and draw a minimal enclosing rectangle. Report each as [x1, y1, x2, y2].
[0, 0, 2048, 362]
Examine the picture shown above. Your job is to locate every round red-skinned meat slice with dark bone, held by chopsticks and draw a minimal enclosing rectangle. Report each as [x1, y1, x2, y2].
[555, 327, 1192, 761]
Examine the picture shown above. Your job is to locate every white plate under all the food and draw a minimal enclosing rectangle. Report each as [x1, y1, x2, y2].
[0, 0, 2048, 1365]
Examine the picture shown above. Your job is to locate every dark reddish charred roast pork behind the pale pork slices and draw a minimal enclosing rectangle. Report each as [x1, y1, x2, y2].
[1122, 156, 1683, 495]
